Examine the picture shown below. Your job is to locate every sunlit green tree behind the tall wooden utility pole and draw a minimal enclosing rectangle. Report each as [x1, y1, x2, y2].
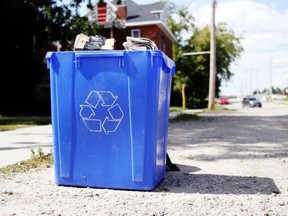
[167, 7, 243, 108]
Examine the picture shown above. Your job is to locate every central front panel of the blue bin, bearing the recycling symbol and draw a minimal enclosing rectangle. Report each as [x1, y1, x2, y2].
[75, 55, 131, 188]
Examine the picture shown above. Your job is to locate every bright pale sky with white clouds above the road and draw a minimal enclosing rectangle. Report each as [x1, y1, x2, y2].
[86, 0, 288, 96]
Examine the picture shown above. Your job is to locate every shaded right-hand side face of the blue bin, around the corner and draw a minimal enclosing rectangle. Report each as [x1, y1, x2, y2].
[146, 52, 171, 184]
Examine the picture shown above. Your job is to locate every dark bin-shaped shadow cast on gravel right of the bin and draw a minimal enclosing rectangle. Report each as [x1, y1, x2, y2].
[154, 165, 280, 195]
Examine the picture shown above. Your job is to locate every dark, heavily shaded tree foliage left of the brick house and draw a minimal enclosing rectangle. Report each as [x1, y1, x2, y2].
[0, 0, 95, 115]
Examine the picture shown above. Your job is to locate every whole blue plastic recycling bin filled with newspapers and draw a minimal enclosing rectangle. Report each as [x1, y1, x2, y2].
[46, 50, 175, 190]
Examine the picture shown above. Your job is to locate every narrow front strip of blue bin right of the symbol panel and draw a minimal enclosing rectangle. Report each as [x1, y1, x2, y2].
[127, 52, 154, 187]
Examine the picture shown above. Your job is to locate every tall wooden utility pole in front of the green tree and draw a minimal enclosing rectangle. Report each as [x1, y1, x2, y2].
[208, 0, 216, 110]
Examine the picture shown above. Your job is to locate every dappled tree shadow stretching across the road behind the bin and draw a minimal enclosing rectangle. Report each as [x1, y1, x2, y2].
[168, 116, 288, 161]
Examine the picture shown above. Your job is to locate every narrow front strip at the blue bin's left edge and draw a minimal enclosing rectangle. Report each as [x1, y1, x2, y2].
[50, 53, 74, 182]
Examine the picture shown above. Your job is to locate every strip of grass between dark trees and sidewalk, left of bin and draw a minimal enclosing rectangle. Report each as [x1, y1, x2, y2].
[0, 117, 51, 131]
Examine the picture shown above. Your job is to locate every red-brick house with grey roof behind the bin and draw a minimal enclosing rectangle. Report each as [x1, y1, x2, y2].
[87, 0, 176, 59]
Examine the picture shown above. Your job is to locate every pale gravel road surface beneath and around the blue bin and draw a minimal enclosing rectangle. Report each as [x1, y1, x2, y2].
[0, 101, 288, 216]
